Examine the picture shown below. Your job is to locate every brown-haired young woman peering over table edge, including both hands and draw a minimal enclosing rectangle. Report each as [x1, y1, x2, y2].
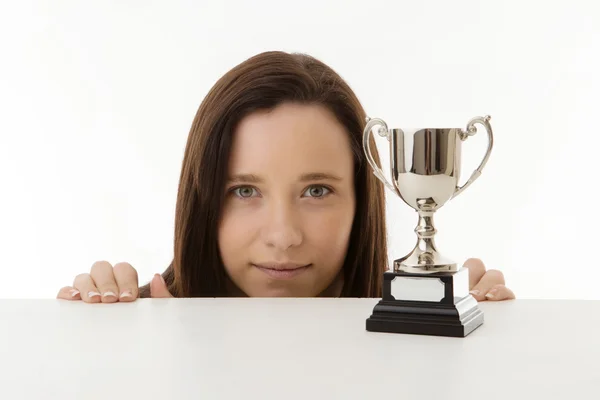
[58, 52, 514, 303]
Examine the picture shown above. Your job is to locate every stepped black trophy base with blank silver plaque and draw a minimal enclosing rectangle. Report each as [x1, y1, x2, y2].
[366, 268, 484, 337]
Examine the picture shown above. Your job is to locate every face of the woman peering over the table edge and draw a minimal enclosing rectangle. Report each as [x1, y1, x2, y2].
[219, 104, 355, 297]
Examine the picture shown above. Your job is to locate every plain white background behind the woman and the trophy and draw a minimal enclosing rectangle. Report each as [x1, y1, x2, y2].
[0, 0, 600, 299]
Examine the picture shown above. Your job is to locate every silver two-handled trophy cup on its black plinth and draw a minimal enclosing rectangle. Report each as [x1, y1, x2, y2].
[363, 116, 493, 337]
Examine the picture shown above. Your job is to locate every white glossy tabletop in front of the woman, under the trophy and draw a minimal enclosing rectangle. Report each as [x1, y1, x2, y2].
[0, 298, 600, 400]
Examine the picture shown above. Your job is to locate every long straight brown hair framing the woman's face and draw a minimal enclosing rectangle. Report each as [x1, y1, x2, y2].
[140, 51, 387, 297]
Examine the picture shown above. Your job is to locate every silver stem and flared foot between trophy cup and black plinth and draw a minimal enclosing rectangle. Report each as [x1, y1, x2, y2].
[394, 204, 458, 273]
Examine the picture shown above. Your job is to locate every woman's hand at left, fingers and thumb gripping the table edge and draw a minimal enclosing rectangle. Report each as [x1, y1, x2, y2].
[56, 261, 173, 303]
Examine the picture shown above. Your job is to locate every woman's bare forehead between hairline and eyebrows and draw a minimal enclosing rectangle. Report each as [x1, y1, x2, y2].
[229, 104, 353, 174]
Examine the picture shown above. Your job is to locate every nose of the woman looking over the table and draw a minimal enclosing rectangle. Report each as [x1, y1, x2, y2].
[262, 202, 303, 251]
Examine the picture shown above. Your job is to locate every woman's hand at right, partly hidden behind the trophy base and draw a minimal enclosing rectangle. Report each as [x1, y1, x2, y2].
[463, 258, 515, 301]
